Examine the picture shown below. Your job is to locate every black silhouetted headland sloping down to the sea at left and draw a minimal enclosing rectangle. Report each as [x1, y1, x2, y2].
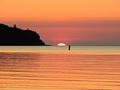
[0, 24, 45, 46]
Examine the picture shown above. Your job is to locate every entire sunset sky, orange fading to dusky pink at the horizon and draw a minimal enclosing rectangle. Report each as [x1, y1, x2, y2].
[0, 0, 120, 45]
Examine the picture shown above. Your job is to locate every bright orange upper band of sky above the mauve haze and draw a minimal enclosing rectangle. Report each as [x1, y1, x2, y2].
[0, 0, 120, 21]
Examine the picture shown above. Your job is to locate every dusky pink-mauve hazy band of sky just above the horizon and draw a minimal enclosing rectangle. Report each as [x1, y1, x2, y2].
[1, 21, 120, 45]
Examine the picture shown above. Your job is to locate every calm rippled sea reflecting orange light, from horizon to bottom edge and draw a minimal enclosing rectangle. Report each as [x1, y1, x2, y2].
[0, 47, 120, 90]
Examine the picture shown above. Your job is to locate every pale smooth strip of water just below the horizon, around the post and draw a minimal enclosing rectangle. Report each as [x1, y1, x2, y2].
[0, 46, 120, 55]
